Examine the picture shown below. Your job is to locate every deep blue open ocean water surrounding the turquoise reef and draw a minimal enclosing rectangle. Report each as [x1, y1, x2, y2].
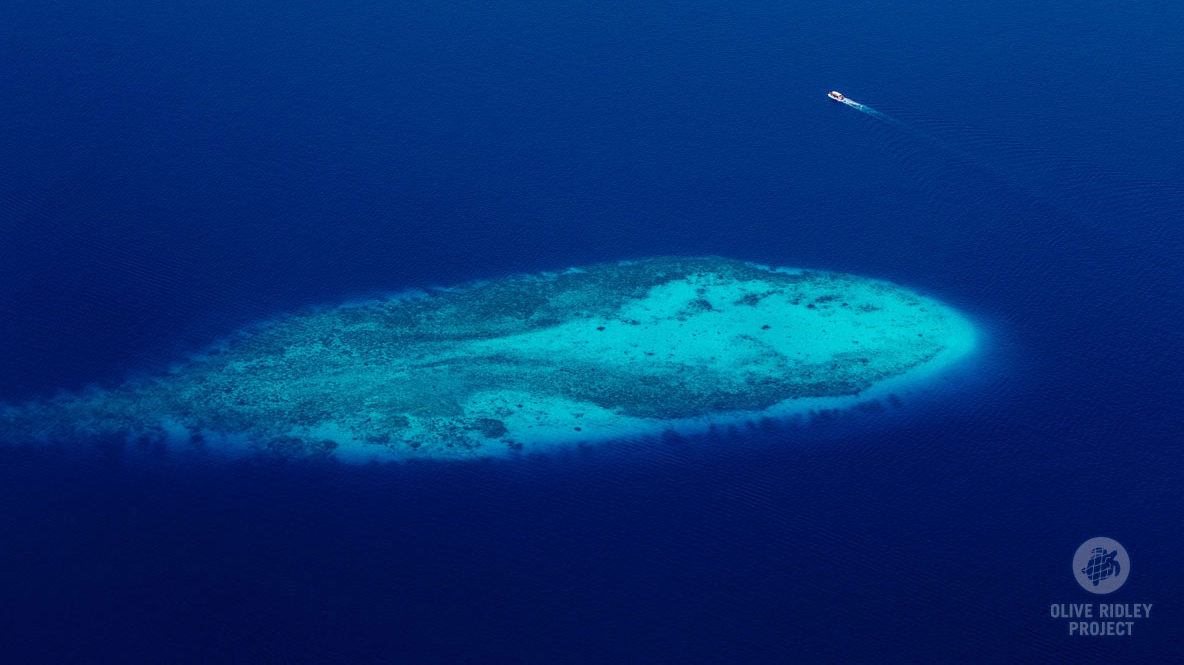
[0, 0, 1184, 664]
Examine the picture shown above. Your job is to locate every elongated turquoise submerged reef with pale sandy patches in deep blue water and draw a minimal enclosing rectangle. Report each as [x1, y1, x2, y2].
[0, 257, 973, 460]
